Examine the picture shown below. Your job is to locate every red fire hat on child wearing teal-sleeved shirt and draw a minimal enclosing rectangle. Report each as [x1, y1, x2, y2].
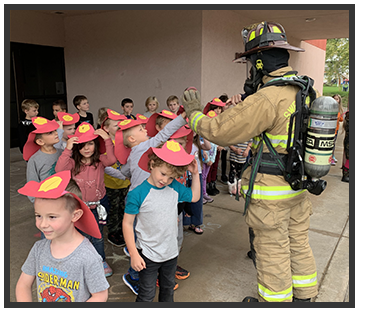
[138, 140, 195, 172]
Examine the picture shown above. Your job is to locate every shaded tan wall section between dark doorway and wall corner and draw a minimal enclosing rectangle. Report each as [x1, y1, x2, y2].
[65, 11, 202, 117]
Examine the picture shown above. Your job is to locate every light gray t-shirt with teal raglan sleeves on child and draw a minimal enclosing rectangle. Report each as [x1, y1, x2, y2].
[124, 180, 193, 263]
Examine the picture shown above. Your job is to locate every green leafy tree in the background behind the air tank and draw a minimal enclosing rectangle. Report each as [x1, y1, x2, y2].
[325, 38, 349, 83]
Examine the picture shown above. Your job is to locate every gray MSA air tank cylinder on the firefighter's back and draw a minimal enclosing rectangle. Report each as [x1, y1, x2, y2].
[304, 96, 339, 179]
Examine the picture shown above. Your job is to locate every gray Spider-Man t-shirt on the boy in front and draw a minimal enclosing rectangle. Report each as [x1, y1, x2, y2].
[22, 238, 109, 302]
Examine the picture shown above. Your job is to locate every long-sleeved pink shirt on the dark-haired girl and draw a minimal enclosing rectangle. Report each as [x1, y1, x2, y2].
[56, 138, 117, 202]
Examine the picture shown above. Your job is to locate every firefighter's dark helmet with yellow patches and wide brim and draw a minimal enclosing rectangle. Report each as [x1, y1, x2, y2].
[237, 21, 304, 57]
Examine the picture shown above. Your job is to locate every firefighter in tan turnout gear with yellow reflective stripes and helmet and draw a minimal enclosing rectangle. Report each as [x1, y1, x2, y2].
[183, 22, 318, 302]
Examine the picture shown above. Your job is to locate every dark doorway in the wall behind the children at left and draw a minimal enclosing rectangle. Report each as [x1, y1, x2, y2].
[10, 42, 67, 148]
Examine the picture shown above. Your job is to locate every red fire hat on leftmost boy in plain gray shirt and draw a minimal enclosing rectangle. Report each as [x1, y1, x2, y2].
[23, 117, 60, 161]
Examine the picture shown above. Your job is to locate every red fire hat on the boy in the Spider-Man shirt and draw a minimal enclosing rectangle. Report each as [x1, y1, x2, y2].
[18, 170, 101, 239]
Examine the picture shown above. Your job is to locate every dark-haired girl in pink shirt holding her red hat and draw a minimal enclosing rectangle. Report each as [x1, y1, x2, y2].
[56, 123, 116, 277]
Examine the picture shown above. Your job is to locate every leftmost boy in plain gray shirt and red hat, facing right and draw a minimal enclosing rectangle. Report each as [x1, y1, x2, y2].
[23, 117, 62, 203]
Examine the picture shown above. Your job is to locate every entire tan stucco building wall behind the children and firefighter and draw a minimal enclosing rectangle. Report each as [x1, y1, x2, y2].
[10, 10, 325, 120]
